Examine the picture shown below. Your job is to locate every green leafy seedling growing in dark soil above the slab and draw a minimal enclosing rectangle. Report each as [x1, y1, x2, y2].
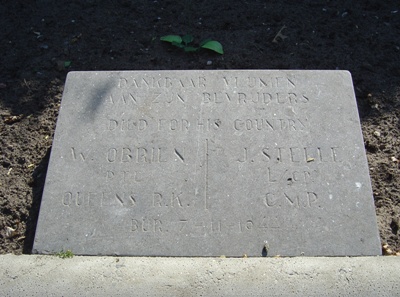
[160, 35, 224, 55]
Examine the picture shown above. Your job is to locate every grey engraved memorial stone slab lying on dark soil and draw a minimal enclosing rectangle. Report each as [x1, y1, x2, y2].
[34, 70, 381, 256]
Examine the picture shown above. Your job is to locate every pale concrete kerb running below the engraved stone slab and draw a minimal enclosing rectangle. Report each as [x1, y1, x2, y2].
[0, 254, 400, 296]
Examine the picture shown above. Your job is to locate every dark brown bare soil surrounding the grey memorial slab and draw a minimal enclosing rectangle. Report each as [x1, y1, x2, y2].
[0, 0, 400, 254]
